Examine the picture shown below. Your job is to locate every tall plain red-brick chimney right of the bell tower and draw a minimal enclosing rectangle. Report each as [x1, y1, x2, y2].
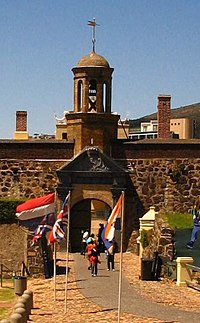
[158, 94, 171, 139]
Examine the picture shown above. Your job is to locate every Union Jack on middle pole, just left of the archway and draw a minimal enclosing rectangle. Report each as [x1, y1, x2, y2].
[49, 194, 69, 244]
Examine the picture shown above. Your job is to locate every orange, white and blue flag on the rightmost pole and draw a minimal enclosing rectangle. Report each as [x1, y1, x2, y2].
[101, 194, 122, 249]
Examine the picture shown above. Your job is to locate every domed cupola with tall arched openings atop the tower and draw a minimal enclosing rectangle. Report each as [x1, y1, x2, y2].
[72, 51, 114, 113]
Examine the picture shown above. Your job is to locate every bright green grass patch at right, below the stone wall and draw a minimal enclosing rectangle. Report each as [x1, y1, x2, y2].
[166, 213, 193, 229]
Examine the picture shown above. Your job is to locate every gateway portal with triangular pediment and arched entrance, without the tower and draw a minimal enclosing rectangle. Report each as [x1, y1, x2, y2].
[57, 146, 130, 252]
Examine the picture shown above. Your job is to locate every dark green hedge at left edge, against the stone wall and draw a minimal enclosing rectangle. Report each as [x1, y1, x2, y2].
[0, 199, 24, 224]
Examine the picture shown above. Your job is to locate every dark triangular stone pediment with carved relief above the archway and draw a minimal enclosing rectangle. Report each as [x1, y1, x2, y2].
[58, 147, 127, 173]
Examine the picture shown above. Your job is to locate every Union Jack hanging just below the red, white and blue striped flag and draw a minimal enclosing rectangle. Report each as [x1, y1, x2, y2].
[32, 213, 55, 245]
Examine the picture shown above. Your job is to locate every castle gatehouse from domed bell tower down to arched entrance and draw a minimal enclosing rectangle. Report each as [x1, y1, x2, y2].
[56, 51, 142, 251]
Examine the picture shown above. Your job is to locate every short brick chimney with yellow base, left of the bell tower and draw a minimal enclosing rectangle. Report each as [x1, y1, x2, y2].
[14, 111, 28, 140]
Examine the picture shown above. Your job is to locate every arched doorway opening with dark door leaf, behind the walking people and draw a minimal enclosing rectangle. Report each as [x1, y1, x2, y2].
[69, 199, 110, 252]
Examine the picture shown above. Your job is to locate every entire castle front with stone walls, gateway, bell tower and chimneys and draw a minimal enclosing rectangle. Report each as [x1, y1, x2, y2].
[0, 38, 200, 251]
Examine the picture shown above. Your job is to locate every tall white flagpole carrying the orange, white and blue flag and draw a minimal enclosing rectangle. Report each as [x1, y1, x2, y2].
[117, 191, 124, 323]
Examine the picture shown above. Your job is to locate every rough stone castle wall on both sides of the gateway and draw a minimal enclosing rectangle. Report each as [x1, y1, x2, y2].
[0, 141, 200, 213]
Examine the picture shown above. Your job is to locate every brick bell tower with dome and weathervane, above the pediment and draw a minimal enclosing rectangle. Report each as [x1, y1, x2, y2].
[65, 20, 120, 155]
